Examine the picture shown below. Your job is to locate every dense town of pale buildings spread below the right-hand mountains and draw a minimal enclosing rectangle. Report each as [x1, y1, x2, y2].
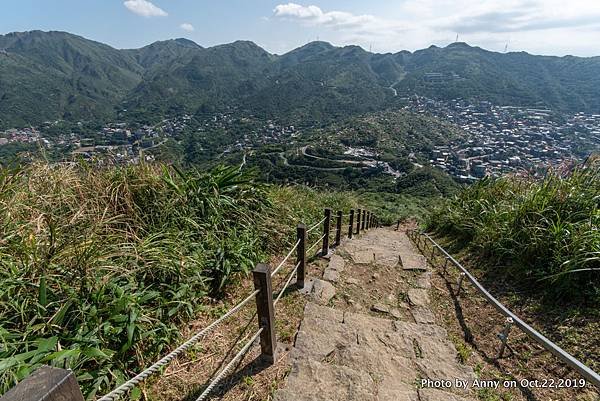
[405, 97, 600, 182]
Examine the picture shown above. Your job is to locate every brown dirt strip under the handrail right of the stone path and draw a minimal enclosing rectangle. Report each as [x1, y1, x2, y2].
[424, 231, 600, 401]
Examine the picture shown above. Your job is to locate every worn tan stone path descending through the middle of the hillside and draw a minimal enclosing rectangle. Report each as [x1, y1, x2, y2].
[275, 229, 475, 401]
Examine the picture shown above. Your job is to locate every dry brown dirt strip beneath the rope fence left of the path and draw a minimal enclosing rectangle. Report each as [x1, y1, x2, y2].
[142, 255, 326, 401]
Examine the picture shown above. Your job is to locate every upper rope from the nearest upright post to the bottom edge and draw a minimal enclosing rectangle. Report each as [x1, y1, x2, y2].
[97, 290, 260, 401]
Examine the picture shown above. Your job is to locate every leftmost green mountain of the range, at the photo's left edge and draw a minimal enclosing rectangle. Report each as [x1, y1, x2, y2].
[0, 31, 144, 126]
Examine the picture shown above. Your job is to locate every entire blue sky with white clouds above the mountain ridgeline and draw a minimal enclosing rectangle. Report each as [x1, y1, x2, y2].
[0, 0, 600, 56]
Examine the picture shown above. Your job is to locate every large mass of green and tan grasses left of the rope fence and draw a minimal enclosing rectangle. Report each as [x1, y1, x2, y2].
[0, 163, 355, 397]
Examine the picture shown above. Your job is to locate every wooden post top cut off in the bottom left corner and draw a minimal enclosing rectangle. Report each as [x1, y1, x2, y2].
[0, 366, 84, 401]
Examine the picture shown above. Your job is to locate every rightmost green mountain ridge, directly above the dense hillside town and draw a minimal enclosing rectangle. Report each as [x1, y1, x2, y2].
[395, 43, 600, 112]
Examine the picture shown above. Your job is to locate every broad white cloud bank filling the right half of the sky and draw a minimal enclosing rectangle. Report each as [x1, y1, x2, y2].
[271, 0, 600, 55]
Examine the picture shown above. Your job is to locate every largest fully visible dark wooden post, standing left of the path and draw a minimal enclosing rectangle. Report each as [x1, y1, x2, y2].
[252, 263, 277, 365]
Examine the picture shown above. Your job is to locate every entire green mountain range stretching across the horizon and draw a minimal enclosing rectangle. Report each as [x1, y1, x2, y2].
[0, 31, 600, 127]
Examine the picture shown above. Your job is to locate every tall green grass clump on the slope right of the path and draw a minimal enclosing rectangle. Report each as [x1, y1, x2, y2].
[428, 158, 600, 302]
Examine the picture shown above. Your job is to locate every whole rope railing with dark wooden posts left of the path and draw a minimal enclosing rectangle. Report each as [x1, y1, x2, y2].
[4, 209, 376, 401]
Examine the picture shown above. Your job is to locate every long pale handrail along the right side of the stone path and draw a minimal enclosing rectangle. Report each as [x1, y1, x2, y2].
[418, 232, 600, 387]
